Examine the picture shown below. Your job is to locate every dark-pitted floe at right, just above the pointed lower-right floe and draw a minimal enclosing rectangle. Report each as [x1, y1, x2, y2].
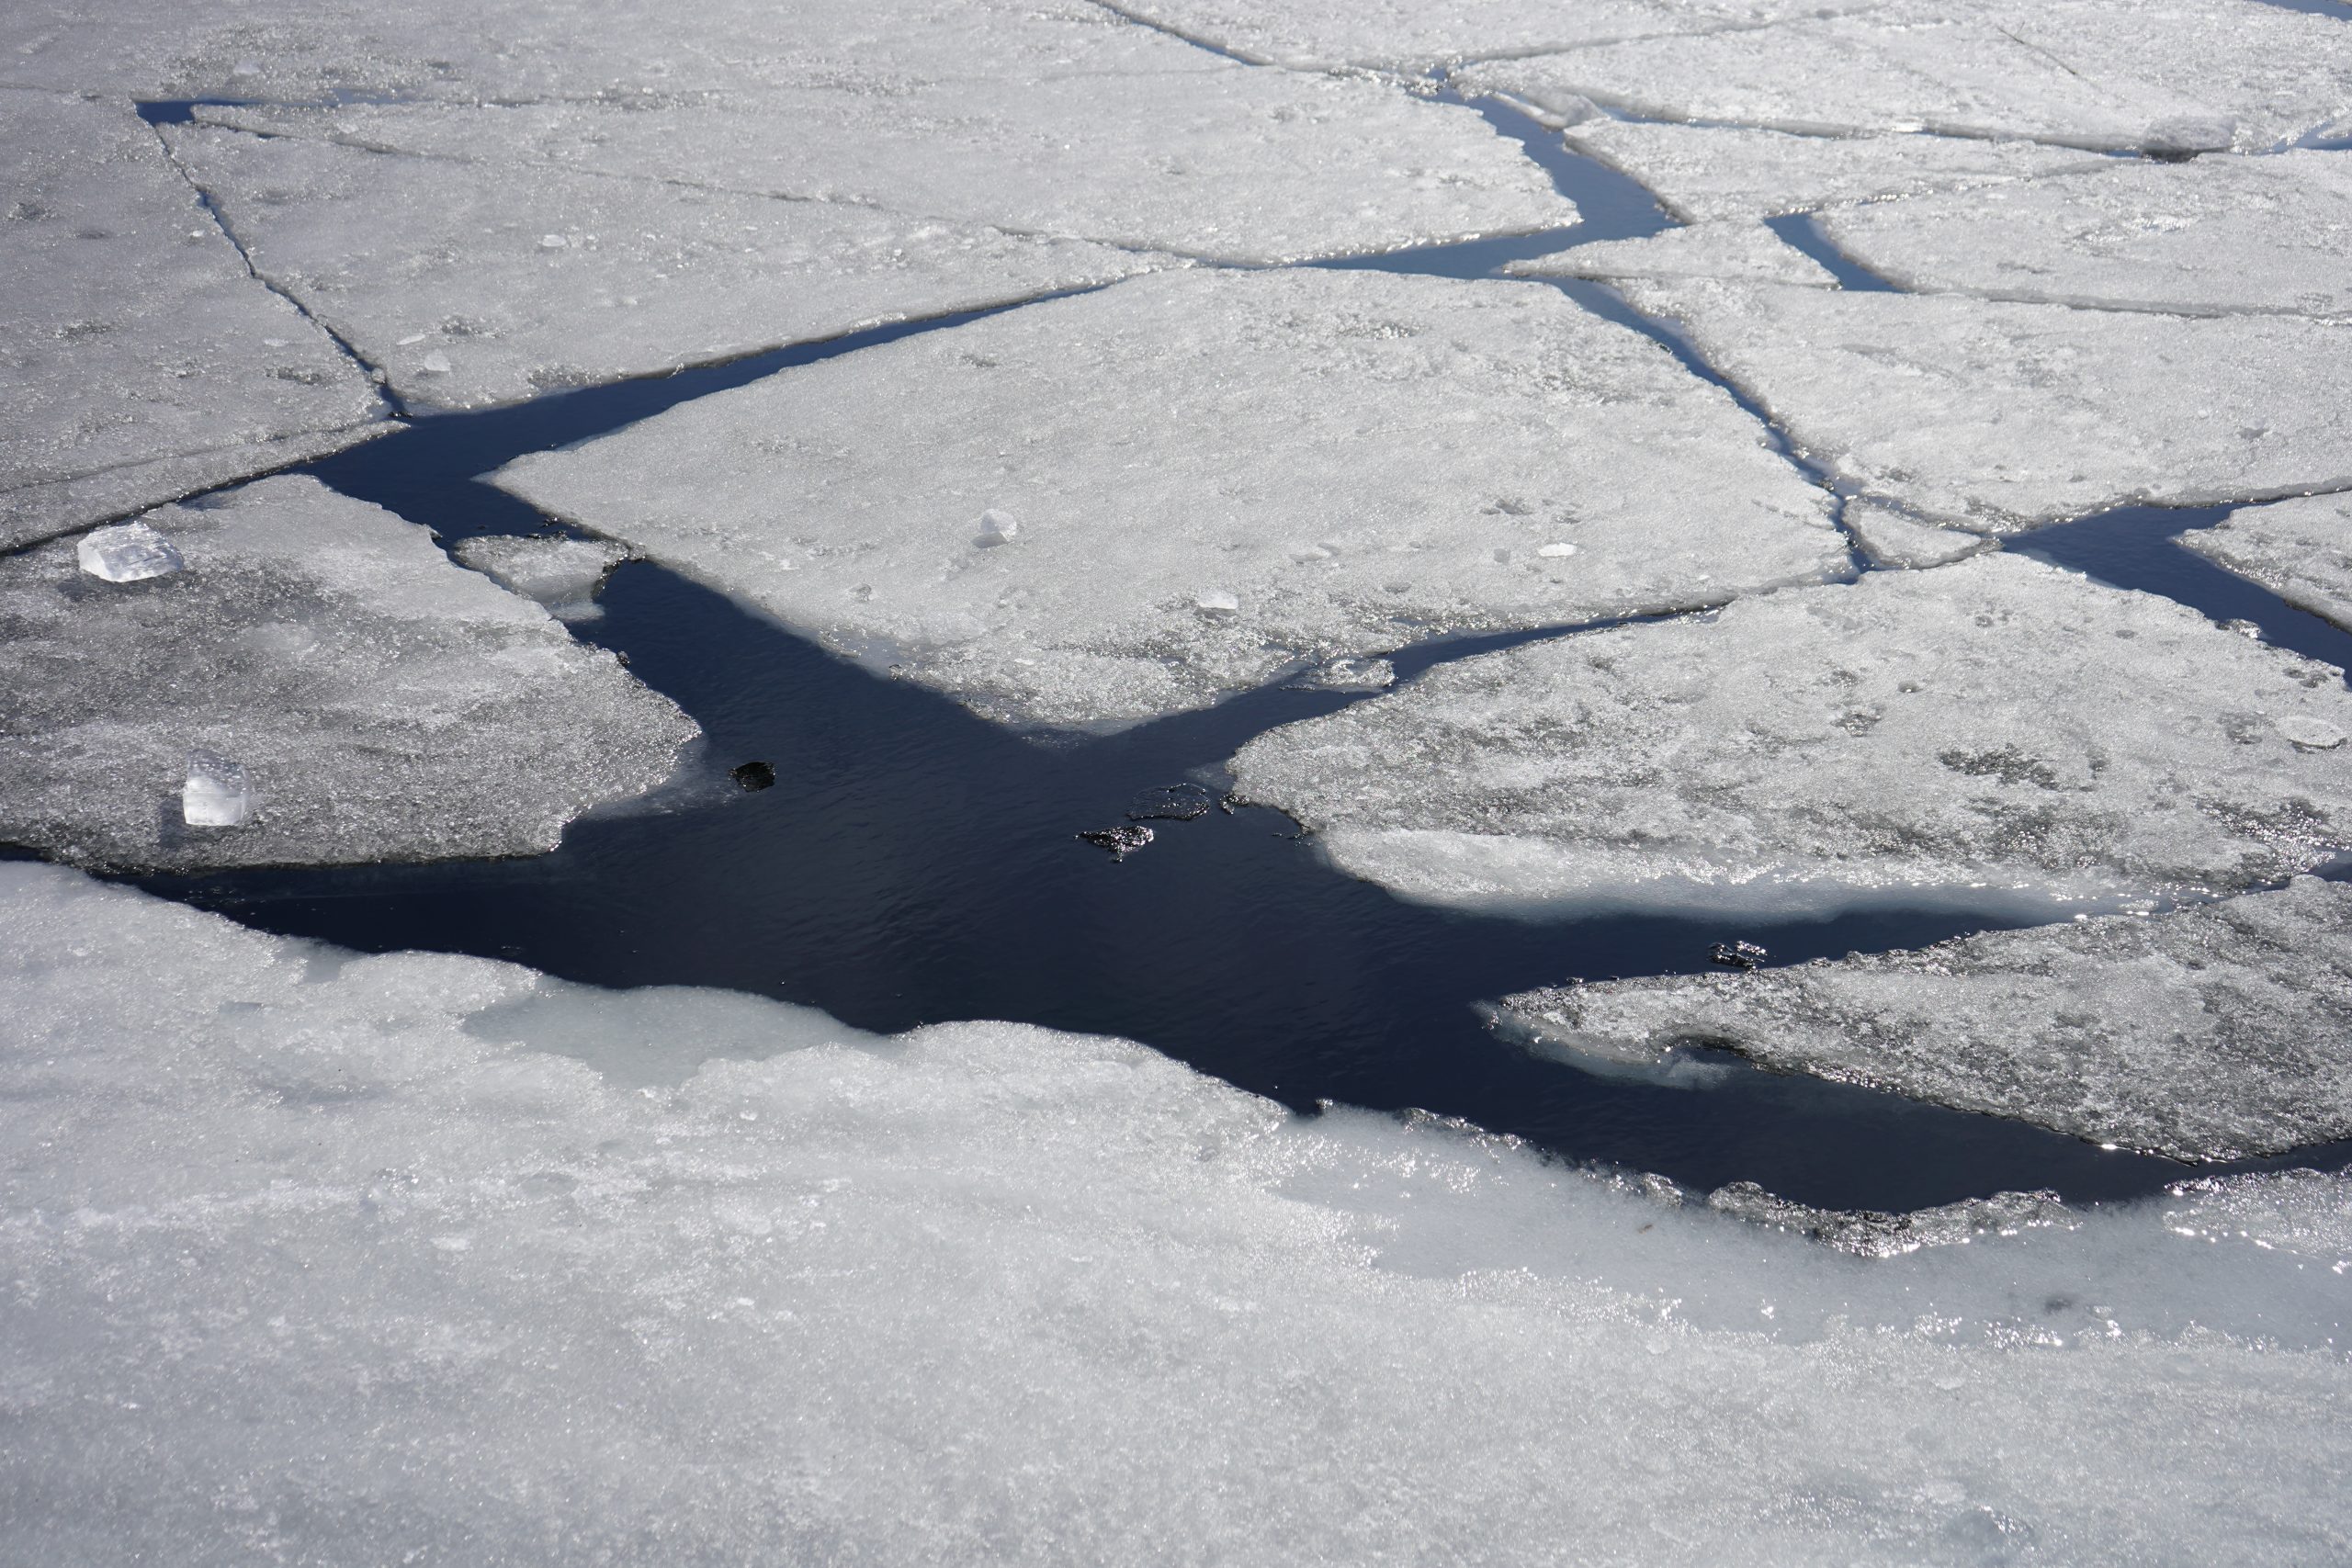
[1232, 552, 2352, 917]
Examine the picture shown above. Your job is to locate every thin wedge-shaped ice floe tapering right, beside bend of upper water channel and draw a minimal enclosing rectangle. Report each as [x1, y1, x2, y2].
[1566, 120, 2108, 223]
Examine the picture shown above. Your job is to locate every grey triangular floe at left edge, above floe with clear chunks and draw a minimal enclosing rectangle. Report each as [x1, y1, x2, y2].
[0, 89, 390, 547]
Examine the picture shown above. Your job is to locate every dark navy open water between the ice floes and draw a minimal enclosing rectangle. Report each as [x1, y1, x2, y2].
[101, 95, 2352, 1211]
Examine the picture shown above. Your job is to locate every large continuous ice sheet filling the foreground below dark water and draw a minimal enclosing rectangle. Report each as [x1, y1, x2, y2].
[0, 865, 2352, 1565]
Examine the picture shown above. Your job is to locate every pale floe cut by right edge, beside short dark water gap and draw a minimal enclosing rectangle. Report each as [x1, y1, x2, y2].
[1823, 152, 2352, 317]
